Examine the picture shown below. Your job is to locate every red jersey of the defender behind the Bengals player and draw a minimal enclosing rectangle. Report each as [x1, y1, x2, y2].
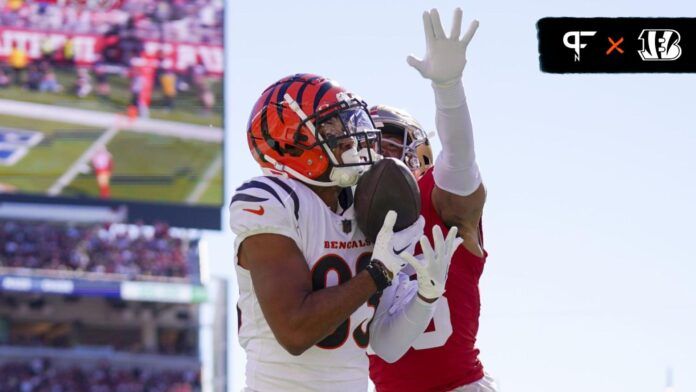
[370, 169, 487, 392]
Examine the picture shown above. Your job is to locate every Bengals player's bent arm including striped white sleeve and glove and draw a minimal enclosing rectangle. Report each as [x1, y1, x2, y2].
[230, 179, 423, 355]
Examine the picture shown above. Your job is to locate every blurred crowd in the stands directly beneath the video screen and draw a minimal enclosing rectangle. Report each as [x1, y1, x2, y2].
[0, 220, 189, 279]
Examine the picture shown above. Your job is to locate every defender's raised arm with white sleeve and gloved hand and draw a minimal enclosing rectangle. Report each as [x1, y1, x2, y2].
[408, 8, 486, 254]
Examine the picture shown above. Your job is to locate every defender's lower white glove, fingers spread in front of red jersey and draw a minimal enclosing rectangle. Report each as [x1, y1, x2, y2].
[401, 226, 464, 300]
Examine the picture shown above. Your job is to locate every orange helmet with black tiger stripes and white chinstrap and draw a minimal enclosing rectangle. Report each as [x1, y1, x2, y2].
[247, 74, 380, 187]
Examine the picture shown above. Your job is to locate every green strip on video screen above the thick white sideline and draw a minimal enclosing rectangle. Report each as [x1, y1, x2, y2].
[0, 70, 223, 127]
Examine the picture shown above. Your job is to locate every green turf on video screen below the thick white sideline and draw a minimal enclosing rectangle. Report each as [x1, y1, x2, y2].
[0, 116, 222, 206]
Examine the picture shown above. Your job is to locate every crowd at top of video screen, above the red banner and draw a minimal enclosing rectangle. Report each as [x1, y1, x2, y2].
[0, 0, 224, 45]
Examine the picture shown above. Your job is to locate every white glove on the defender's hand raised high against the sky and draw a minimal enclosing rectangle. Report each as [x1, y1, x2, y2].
[406, 8, 479, 87]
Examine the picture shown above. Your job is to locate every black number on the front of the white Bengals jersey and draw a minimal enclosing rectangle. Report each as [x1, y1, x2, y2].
[312, 253, 381, 350]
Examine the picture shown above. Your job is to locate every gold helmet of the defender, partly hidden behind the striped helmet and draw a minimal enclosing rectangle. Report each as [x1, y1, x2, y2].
[370, 105, 433, 175]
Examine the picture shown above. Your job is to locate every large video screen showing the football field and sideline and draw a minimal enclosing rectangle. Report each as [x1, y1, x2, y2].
[0, 0, 224, 228]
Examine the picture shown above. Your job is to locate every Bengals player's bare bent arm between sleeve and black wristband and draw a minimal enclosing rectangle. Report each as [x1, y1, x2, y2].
[238, 234, 377, 355]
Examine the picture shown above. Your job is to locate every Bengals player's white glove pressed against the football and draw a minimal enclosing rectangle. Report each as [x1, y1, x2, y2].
[372, 211, 425, 279]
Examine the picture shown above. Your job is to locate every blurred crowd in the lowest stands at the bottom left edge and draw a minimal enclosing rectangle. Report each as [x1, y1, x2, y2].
[0, 358, 201, 392]
